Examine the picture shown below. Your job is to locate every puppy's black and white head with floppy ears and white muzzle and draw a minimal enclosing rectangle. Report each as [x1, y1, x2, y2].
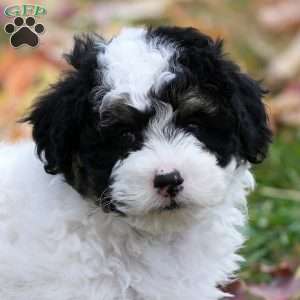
[26, 27, 271, 230]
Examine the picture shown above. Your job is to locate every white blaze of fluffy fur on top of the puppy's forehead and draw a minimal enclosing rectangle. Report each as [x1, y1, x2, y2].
[98, 28, 174, 109]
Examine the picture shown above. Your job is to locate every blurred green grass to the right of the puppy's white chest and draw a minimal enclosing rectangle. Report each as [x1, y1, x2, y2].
[241, 129, 300, 282]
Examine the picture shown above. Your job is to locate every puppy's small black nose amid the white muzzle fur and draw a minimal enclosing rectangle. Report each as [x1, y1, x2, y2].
[154, 170, 183, 196]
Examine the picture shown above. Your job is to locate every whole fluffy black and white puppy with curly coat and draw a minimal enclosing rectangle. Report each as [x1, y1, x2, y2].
[0, 27, 271, 300]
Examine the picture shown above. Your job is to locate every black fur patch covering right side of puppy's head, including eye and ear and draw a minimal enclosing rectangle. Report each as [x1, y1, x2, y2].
[147, 27, 271, 166]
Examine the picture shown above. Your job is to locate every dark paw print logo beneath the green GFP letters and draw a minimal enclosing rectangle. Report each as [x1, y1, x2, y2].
[4, 17, 45, 48]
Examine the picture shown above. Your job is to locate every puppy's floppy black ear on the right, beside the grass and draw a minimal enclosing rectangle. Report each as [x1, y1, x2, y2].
[232, 71, 272, 163]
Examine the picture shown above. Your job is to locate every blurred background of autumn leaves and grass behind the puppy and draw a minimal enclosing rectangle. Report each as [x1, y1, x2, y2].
[0, 0, 300, 300]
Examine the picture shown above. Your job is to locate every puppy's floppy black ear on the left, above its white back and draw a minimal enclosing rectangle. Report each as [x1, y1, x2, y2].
[23, 36, 102, 174]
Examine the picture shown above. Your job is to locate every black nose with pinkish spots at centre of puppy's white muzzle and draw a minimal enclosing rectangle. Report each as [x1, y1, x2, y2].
[153, 170, 184, 198]
